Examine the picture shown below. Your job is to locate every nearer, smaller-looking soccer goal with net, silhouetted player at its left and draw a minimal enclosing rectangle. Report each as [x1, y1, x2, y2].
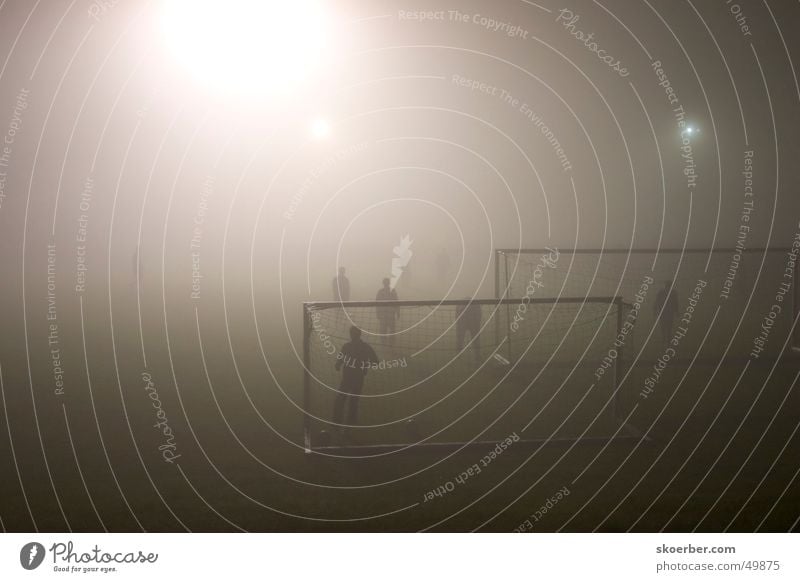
[303, 295, 638, 454]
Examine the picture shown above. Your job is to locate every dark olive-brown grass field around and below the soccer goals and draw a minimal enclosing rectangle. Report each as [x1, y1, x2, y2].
[0, 296, 800, 531]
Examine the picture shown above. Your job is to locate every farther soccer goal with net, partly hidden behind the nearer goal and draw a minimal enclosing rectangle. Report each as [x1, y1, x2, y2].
[495, 248, 800, 363]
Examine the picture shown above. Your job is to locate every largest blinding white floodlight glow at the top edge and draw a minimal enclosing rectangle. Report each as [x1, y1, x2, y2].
[161, 0, 328, 94]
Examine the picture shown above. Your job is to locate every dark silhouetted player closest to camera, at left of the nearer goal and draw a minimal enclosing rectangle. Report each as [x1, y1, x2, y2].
[333, 326, 378, 432]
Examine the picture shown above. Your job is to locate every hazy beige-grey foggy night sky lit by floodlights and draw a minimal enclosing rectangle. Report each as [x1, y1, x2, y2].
[0, 2, 798, 312]
